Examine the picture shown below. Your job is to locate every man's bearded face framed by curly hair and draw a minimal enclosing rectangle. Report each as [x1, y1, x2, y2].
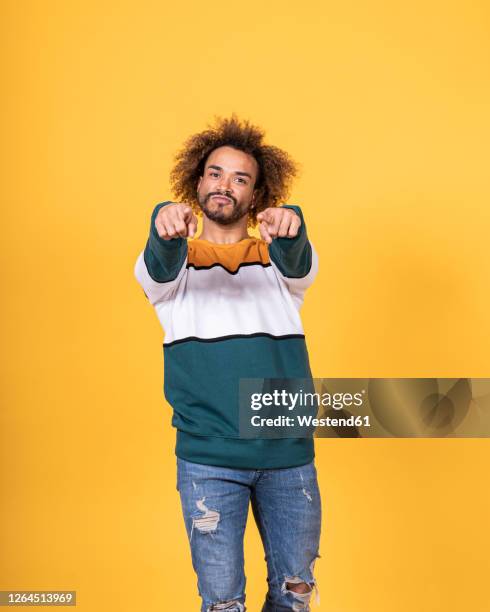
[197, 146, 259, 225]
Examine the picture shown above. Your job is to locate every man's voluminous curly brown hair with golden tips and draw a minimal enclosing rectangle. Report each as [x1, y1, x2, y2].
[170, 113, 299, 227]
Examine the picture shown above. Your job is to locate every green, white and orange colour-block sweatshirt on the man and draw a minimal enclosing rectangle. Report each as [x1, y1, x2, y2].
[134, 201, 318, 469]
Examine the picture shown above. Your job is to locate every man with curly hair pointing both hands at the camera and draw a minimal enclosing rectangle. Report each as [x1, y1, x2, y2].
[135, 115, 321, 612]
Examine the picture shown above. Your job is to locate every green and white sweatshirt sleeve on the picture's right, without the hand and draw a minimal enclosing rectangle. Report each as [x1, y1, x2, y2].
[269, 204, 318, 297]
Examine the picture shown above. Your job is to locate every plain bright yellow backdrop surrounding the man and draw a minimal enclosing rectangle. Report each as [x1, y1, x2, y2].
[0, 0, 490, 612]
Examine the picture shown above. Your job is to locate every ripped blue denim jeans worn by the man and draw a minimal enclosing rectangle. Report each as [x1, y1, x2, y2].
[177, 458, 321, 612]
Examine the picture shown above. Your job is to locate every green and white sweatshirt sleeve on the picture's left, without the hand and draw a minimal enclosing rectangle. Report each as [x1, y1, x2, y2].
[134, 201, 187, 305]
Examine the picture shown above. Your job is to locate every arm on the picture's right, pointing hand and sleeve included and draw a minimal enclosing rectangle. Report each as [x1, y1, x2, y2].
[257, 204, 318, 294]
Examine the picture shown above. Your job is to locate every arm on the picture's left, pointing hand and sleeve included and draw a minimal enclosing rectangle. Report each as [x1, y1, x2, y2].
[134, 201, 196, 305]
